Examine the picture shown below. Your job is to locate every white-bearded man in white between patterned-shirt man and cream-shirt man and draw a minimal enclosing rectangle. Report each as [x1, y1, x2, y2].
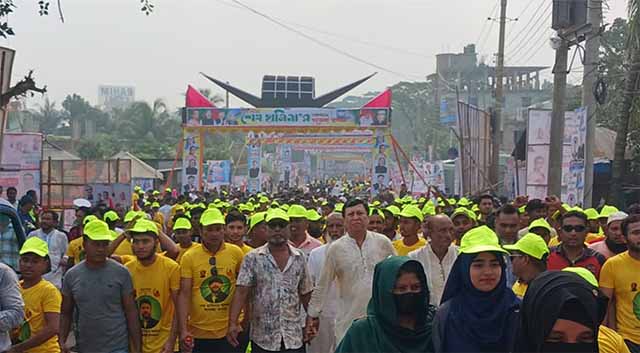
[307, 212, 344, 353]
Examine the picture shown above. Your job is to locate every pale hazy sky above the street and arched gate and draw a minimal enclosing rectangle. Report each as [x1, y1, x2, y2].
[0, 0, 626, 107]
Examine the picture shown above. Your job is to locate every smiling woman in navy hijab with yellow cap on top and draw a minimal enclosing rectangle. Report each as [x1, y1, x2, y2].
[433, 226, 520, 353]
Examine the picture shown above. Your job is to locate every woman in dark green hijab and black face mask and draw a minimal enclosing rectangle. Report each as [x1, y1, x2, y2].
[336, 256, 435, 353]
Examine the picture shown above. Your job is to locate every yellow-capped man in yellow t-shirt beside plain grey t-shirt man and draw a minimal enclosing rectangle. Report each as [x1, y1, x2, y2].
[126, 219, 180, 353]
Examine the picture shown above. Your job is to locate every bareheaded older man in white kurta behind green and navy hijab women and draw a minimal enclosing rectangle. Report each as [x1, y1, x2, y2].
[409, 215, 458, 307]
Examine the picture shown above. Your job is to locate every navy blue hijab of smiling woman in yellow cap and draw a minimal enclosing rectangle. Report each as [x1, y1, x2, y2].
[442, 252, 520, 352]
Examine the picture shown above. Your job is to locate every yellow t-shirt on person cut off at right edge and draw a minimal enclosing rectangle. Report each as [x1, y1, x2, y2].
[600, 251, 640, 344]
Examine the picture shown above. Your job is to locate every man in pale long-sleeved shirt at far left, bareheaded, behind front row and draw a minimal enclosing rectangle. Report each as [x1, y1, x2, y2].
[28, 210, 69, 289]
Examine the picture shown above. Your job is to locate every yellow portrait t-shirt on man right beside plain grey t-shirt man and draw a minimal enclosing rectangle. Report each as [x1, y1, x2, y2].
[125, 256, 180, 353]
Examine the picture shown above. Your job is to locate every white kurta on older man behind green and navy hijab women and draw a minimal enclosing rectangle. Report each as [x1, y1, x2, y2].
[409, 244, 458, 307]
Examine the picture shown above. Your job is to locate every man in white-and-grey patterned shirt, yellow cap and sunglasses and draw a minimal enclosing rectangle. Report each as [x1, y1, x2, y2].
[227, 209, 313, 353]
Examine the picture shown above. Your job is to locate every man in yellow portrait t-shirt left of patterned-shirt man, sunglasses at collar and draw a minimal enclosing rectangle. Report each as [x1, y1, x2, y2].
[178, 208, 243, 353]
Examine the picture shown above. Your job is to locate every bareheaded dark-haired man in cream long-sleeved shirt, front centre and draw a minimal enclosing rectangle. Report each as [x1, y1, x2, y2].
[307, 199, 396, 342]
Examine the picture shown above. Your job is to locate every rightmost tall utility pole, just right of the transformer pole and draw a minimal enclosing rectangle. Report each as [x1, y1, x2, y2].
[582, 0, 602, 208]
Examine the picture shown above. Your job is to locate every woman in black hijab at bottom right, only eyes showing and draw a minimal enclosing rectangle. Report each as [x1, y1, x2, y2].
[516, 268, 628, 353]
